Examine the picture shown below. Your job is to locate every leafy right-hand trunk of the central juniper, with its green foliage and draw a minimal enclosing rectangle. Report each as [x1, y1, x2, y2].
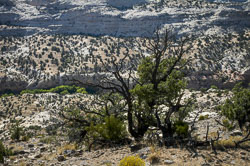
[131, 32, 192, 143]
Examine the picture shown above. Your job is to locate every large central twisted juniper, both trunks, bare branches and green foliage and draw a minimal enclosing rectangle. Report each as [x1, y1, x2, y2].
[70, 30, 191, 143]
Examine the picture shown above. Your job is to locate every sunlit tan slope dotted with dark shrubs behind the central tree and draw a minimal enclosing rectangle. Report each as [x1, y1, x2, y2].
[0, 31, 250, 92]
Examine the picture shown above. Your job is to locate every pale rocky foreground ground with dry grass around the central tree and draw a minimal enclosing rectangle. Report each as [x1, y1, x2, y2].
[0, 89, 250, 166]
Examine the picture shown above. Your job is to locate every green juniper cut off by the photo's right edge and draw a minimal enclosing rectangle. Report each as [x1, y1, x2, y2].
[221, 84, 250, 129]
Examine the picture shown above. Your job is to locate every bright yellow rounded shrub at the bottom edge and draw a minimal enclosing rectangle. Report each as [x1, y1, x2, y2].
[119, 156, 145, 166]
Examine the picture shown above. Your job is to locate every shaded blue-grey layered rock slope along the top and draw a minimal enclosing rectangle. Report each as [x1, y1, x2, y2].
[0, 0, 250, 36]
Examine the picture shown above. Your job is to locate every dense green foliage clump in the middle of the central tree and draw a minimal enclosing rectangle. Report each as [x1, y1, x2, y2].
[132, 56, 186, 109]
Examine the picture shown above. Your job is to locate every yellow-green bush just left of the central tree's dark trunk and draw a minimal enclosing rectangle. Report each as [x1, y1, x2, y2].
[87, 115, 127, 141]
